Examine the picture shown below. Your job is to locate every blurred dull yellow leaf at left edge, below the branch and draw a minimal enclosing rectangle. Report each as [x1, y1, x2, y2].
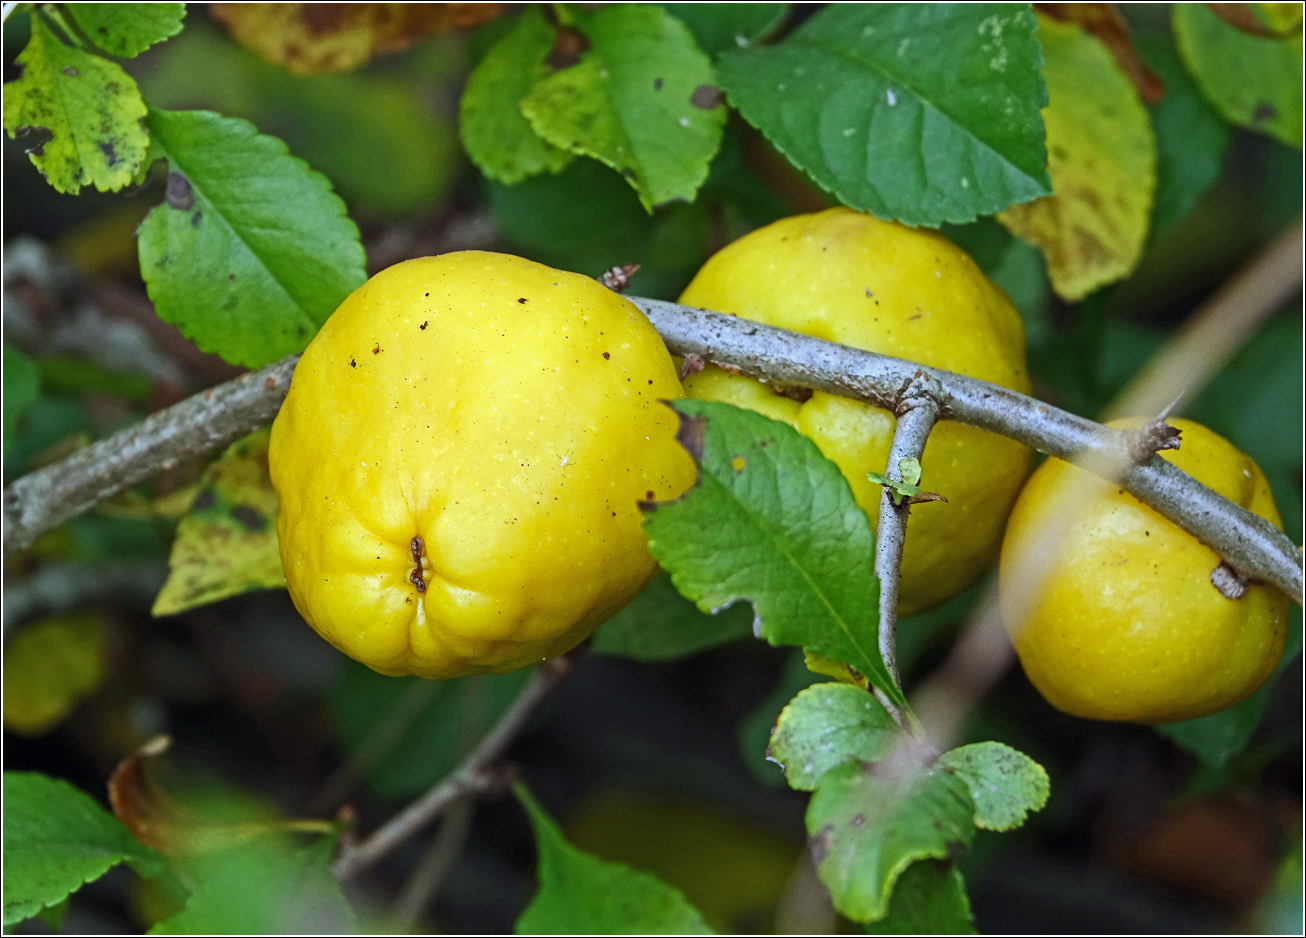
[4, 613, 108, 736]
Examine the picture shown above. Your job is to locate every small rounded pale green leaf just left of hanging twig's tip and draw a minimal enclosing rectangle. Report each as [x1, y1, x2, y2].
[769, 683, 902, 792]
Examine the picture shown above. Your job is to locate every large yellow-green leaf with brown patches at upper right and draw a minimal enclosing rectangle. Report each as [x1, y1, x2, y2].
[998, 17, 1156, 300]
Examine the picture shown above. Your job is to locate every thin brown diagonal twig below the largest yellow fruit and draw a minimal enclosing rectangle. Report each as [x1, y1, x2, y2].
[332, 655, 575, 879]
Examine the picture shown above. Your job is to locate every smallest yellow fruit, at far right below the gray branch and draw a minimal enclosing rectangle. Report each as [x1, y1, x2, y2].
[1000, 419, 1288, 724]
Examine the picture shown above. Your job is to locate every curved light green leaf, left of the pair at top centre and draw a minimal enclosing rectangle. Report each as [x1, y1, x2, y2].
[458, 5, 572, 186]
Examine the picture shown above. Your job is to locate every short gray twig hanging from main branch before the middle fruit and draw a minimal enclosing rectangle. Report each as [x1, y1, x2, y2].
[875, 380, 939, 690]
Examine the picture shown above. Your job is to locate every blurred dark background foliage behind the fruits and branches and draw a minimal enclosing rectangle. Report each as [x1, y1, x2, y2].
[3, 4, 1302, 933]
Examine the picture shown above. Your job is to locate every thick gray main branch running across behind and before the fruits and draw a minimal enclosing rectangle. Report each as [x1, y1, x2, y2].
[4, 297, 1302, 605]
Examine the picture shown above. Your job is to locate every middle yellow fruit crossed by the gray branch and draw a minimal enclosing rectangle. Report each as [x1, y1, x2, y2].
[680, 209, 1030, 615]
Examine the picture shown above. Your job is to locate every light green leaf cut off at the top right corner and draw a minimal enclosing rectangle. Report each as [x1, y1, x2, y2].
[1173, 4, 1302, 149]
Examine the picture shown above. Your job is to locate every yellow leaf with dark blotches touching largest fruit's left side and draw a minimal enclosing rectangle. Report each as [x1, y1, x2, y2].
[151, 430, 286, 615]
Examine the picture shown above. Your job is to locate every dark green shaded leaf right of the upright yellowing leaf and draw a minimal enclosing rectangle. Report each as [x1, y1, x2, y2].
[1134, 33, 1230, 233]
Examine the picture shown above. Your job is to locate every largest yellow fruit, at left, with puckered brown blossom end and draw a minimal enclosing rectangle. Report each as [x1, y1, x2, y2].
[268, 251, 695, 679]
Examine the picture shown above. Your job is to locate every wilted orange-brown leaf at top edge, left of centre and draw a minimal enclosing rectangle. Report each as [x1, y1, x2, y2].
[210, 3, 504, 74]
